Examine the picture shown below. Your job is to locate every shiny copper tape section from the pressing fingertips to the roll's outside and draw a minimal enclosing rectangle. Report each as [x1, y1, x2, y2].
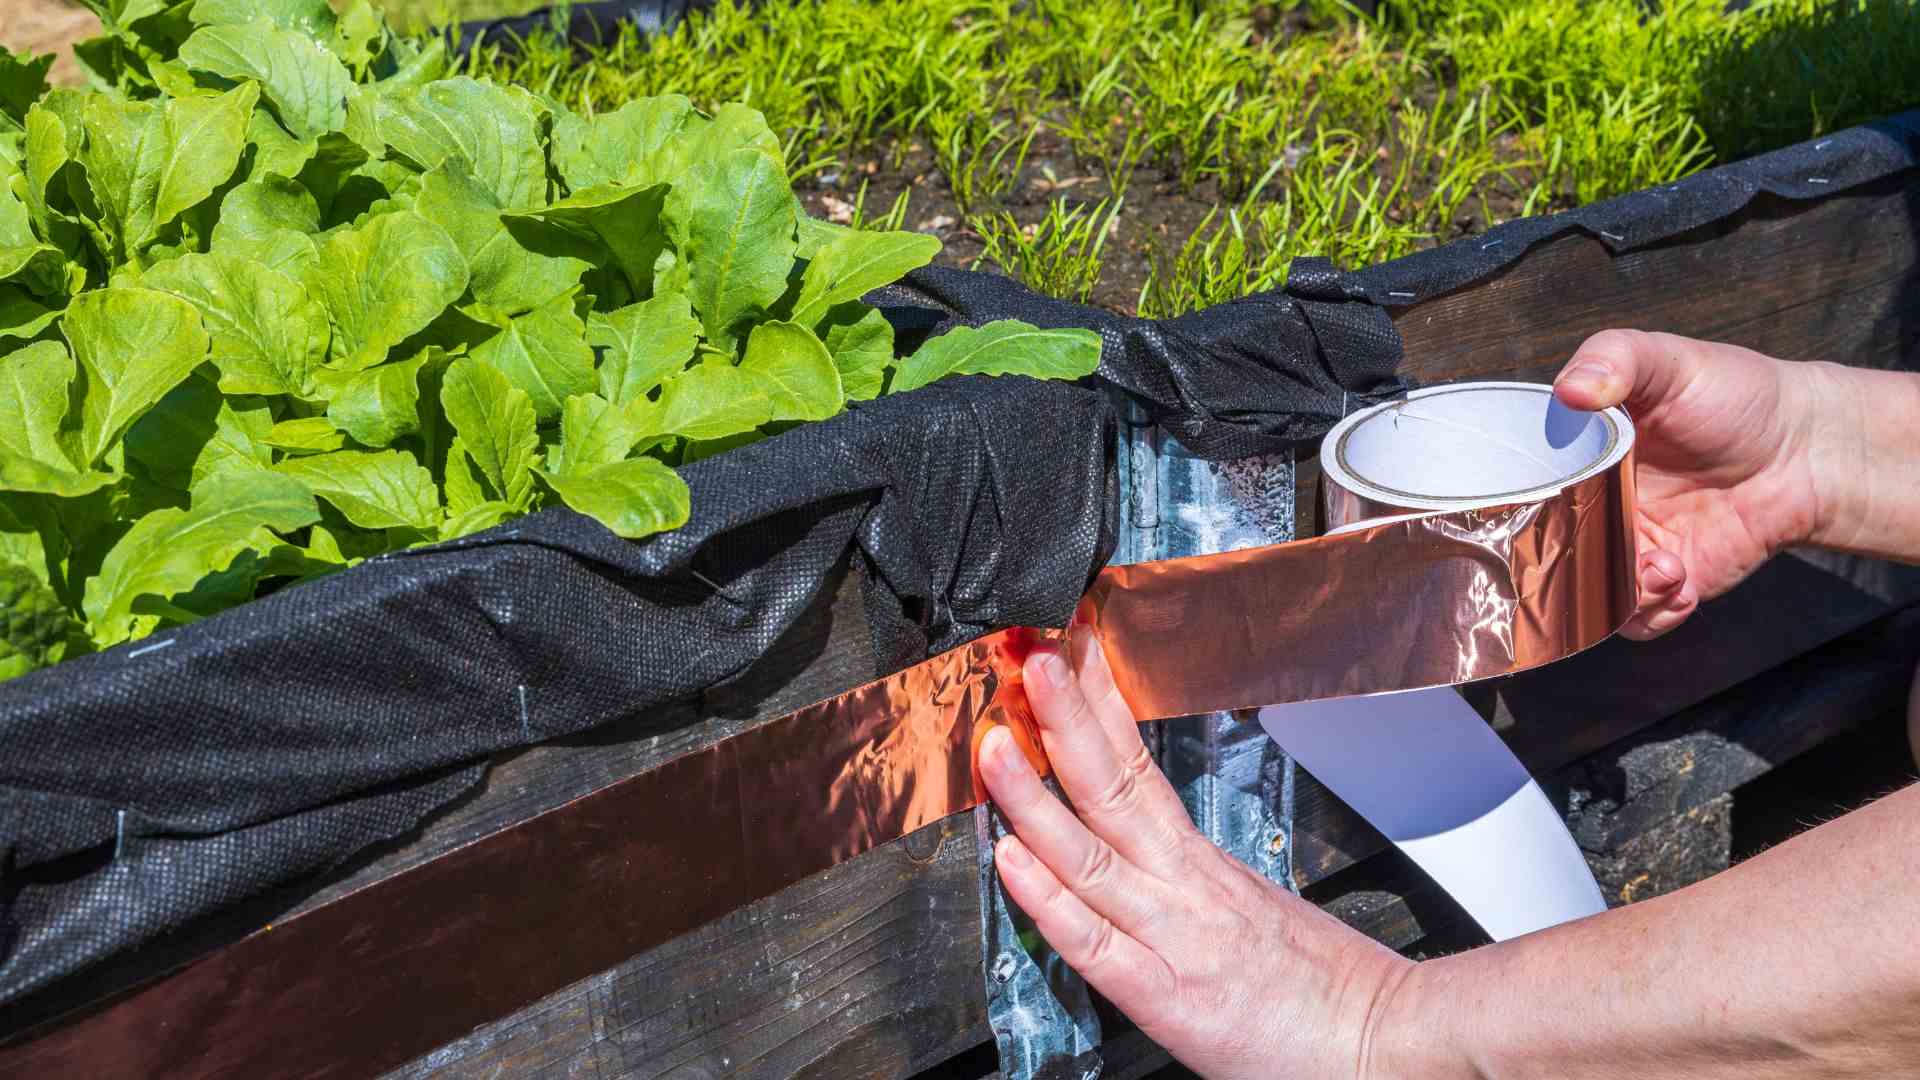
[1077, 454, 1636, 721]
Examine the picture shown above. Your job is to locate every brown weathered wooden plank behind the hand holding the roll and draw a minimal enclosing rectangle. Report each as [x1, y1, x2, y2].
[1394, 175, 1920, 382]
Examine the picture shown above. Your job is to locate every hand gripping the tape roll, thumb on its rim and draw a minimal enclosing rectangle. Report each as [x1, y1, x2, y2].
[1553, 322, 1832, 640]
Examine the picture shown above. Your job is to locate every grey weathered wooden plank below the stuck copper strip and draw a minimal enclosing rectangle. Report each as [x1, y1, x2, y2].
[388, 815, 991, 1080]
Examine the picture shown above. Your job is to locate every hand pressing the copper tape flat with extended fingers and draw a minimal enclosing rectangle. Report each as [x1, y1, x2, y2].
[979, 626, 1413, 1078]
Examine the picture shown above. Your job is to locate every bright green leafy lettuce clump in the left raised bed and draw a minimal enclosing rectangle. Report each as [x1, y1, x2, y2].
[0, 0, 1098, 676]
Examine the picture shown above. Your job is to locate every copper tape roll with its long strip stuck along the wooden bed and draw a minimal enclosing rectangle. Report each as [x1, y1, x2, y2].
[0, 384, 1634, 1076]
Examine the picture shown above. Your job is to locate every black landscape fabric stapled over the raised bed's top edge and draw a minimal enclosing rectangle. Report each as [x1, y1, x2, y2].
[0, 113, 1920, 1005]
